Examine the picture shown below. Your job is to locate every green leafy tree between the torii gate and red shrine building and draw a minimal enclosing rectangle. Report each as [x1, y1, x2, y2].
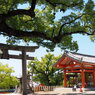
[28, 53, 63, 86]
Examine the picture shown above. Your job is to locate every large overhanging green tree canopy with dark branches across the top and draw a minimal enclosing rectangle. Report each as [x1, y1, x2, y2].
[0, 0, 95, 50]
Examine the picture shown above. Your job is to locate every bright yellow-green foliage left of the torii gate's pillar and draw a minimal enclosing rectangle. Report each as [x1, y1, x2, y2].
[0, 63, 19, 89]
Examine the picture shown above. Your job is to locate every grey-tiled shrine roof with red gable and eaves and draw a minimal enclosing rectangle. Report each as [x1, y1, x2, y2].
[53, 51, 95, 68]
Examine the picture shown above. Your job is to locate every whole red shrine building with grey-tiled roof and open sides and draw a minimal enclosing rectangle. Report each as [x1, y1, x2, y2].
[54, 51, 95, 88]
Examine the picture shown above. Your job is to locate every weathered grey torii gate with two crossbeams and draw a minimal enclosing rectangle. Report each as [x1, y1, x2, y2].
[0, 43, 39, 95]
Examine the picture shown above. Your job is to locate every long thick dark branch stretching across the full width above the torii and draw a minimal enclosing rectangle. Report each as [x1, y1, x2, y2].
[0, 20, 95, 44]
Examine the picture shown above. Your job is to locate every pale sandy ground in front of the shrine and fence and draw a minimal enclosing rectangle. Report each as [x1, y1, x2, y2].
[0, 88, 95, 95]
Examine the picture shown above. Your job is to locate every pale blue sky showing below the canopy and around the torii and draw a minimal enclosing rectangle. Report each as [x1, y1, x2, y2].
[0, 0, 95, 77]
